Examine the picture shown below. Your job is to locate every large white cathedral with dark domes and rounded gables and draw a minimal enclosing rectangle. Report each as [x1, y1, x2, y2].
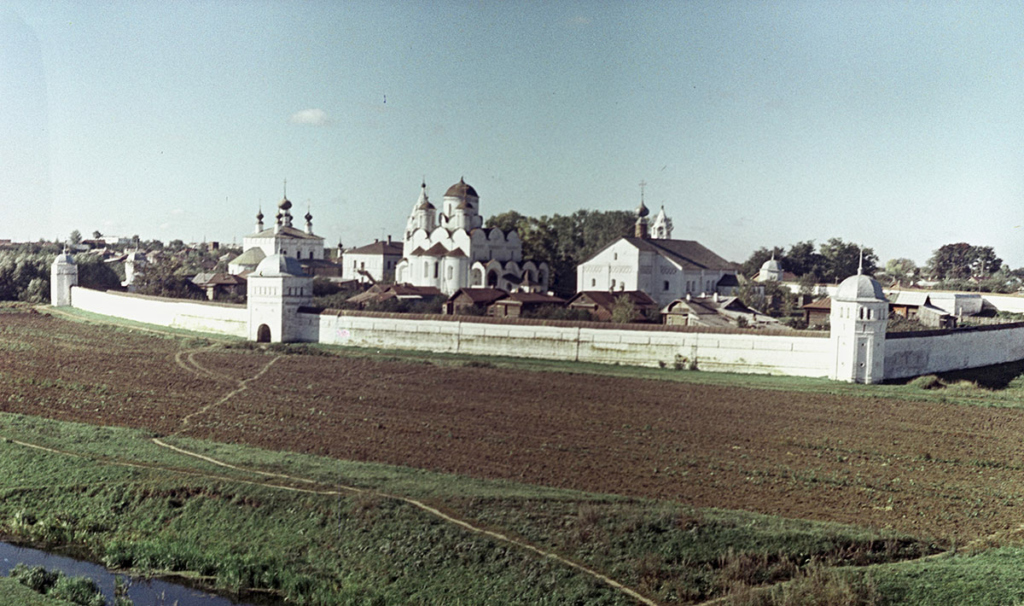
[395, 179, 550, 295]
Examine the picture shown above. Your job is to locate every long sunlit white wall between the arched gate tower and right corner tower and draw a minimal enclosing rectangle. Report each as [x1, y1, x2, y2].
[299, 313, 831, 377]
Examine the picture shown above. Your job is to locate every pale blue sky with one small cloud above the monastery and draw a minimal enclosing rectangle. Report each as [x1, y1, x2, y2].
[0, 0, 1024, 268]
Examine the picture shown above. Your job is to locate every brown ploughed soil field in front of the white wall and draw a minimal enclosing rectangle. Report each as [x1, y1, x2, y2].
[0, 312, 1024, 542]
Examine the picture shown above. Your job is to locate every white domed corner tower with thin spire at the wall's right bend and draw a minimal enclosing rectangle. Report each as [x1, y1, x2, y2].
[828, 252, 889, 383]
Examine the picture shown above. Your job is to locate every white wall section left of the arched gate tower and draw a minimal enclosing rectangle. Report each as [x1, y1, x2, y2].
[71, 287, 249, 338]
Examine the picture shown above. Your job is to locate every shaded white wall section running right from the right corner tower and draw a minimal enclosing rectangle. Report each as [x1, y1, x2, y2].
[885, 322, 1024, 379]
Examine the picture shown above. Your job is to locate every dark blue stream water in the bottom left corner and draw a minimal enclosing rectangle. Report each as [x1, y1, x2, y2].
[0, 542, 260, 606]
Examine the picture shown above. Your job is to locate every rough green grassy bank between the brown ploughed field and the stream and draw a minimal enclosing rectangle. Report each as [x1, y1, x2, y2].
[0, 415, 931, 604]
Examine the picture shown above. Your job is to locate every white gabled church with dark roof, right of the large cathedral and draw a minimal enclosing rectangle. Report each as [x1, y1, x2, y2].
[577, 194, 739, 308]
